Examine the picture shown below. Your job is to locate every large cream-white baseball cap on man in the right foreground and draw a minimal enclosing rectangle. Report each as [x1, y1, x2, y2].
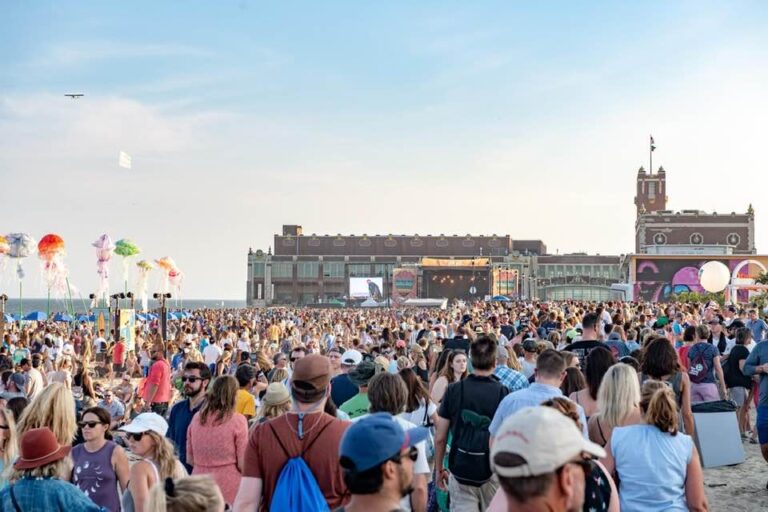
[491, 405, 605, 478]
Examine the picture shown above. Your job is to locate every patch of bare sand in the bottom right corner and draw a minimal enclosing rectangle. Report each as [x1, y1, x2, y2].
[704, 443, 768, 512]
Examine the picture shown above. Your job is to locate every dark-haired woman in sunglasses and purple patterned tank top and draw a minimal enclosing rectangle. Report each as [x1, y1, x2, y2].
[72, 407, 130, 510]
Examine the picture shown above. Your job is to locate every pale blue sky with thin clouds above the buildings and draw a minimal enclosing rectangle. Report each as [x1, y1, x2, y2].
[0, 0, 768, 299]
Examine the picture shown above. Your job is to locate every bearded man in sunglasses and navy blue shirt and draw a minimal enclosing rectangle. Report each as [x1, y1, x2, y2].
[166, 362, 211, 473]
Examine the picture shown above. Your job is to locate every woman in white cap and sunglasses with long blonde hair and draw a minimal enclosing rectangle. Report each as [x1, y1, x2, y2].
[120, 412, 187, 512]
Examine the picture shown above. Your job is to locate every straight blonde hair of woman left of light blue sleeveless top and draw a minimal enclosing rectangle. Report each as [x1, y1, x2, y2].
[597, 363, 640, 428]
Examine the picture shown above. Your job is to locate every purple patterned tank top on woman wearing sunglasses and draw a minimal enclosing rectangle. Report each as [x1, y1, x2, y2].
[72, 441, 120, 512]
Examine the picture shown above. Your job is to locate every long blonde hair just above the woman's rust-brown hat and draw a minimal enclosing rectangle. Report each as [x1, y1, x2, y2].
[18, 382, 77, 445]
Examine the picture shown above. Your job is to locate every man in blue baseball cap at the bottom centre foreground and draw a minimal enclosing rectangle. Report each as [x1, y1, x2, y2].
[338, 412, 428, 512]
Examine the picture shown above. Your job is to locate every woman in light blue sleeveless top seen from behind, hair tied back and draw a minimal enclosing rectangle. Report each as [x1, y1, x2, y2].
[605, 380, 708, 512]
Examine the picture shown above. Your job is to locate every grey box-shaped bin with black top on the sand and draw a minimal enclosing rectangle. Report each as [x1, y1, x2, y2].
[691, 400, 744, 468]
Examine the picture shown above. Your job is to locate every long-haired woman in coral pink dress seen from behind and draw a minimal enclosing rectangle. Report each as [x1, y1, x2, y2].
[187, 375, 248, 504]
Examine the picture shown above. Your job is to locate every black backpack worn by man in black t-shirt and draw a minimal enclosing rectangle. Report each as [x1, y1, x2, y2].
[448, 381, 504, 487]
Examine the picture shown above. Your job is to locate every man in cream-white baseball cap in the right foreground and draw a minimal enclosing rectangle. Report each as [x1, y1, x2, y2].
[491, 406, 606, 512]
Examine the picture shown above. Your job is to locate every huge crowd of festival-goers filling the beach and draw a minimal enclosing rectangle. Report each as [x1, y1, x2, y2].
[0, 301, 768, 512]
